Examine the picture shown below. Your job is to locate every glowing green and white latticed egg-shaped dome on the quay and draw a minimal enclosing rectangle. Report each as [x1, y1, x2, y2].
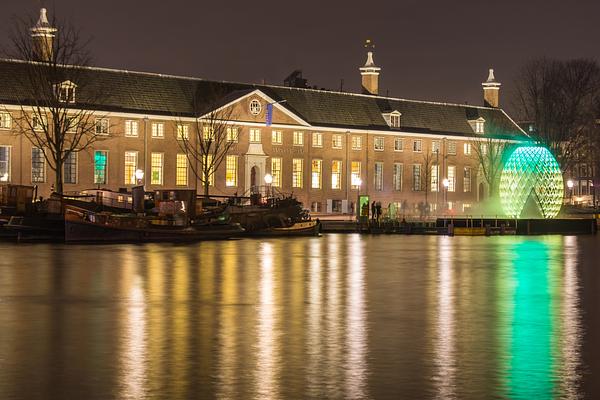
[500, 145, 564, 218]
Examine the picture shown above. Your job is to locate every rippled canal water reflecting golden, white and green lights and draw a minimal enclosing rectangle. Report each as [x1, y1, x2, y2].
[0, 234, 600, 400]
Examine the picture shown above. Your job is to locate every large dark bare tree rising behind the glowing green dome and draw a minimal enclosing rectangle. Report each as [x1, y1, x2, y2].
[514, 58, 600, 171]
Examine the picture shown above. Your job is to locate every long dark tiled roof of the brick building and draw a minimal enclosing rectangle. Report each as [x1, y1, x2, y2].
[0, 60, 525, 139]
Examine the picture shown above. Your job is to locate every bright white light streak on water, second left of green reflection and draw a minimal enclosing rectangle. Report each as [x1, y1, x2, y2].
[346, 235, 368, 399]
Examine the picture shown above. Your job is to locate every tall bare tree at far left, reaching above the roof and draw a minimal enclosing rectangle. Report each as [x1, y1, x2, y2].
[5, 9, 107, 193]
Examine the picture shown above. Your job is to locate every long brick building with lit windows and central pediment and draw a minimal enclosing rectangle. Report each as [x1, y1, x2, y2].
[0, 9, 525, 213]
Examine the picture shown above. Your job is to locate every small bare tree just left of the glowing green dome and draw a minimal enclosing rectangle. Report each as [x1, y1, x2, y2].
[473, 137, 512, 198]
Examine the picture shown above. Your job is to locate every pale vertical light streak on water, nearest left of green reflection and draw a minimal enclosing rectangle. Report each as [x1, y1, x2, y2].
[434, 236, 456, 399]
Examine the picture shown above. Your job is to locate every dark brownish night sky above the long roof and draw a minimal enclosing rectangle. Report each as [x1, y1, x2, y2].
[0, 0, 600, 111]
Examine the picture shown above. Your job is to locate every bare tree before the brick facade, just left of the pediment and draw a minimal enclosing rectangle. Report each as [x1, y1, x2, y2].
[175, 92, 239, 196]
